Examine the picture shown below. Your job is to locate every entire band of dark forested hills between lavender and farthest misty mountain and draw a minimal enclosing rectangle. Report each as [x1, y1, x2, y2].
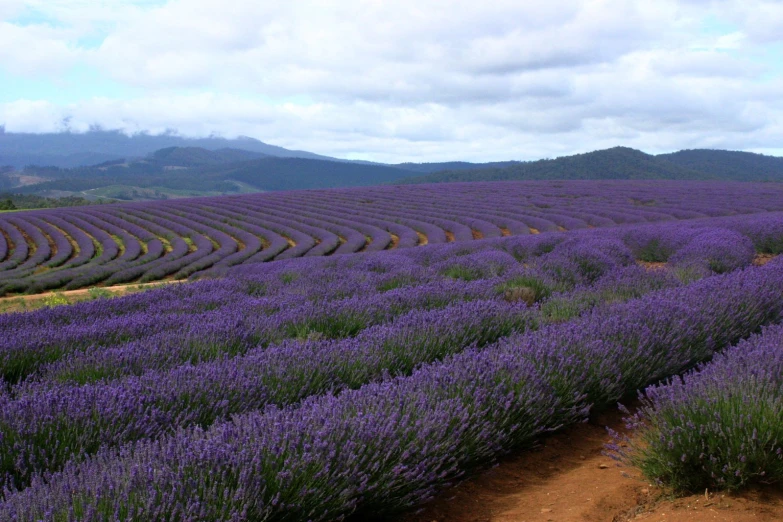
[0, 142, 783, 200]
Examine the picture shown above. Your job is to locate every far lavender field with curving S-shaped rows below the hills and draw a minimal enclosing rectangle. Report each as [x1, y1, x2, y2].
[0, 181, 783, 295]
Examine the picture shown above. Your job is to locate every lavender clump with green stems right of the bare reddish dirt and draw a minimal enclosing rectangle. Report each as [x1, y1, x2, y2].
[612, 325, 783, 491]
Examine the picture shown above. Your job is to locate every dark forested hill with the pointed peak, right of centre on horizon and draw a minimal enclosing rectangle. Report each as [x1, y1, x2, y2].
[399, 147, 717, 183]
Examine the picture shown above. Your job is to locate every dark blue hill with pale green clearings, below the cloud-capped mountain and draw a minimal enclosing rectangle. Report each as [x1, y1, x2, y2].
[9, 147, 422, 199]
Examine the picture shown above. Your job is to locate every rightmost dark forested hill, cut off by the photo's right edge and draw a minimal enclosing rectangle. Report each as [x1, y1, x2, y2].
[656, 149, 783, 181]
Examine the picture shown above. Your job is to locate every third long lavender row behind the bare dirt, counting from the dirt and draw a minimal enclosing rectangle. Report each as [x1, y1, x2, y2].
[0, 280, 496, 383]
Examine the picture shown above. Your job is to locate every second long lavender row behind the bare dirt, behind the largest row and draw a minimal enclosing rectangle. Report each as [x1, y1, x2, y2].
[0, 301, 535, 487]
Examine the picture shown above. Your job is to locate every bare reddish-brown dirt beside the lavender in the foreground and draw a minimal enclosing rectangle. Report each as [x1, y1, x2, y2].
[398, 411, 783, 522]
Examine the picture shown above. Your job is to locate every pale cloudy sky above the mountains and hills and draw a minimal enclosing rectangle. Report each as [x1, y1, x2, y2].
[0, 0, 783, 162]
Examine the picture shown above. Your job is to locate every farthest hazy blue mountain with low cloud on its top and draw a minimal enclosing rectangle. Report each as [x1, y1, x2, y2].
[0, 127, 334, 168]
